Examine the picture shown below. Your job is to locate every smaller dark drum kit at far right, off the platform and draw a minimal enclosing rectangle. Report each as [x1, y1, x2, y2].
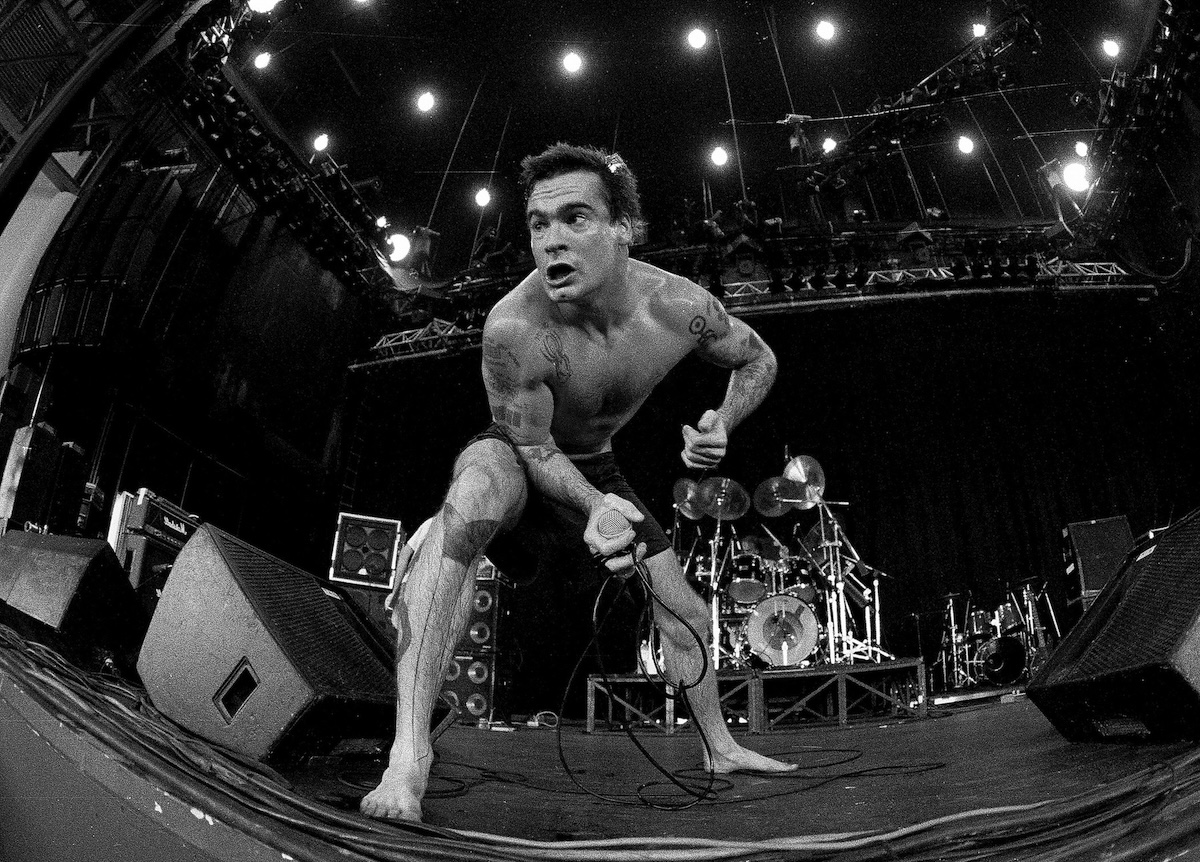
[936, 579, 1062, 688]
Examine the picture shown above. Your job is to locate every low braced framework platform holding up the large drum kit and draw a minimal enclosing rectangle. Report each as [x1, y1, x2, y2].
[587, 658, 928, 734]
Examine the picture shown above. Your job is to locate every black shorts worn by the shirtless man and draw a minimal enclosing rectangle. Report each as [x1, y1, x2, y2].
[467, 423, 671, 583]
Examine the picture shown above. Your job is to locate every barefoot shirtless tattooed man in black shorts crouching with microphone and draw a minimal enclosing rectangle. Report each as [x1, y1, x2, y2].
[361, 144, 796, 820]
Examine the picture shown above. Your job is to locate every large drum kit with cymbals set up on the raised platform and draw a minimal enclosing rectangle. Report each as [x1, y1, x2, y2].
[640, 455, 894, 672]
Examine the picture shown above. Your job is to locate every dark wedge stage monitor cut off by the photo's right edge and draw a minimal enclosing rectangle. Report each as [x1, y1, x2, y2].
[1026, 509, 1200, 741]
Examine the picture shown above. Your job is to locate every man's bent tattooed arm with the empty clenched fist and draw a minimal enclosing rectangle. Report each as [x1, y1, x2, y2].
[682, 295, 778, 468]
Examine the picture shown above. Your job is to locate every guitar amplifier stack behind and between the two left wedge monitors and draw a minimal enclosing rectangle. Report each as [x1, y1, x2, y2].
[108, 487, 200, 613]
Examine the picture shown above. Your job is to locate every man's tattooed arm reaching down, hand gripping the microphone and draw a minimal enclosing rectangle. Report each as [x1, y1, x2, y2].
[484, 315, 643, 564]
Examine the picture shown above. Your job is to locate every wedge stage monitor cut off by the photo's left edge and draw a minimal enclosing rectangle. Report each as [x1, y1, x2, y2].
[0, 532, 148, 677]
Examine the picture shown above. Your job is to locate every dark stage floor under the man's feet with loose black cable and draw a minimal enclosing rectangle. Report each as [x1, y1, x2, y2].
[289, 694, 1189, 840]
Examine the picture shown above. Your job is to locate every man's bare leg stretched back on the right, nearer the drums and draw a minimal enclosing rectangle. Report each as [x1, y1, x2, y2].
[646, 550, 798, 773]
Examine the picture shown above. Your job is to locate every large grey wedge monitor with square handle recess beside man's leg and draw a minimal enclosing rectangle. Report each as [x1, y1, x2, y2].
[138, 525, 396, 760]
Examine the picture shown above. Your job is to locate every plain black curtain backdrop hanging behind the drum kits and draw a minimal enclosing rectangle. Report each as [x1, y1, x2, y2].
[356, 287, 1200, 708]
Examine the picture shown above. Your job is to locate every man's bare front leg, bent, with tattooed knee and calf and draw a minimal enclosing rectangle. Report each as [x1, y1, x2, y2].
[359, 439, 527, 820]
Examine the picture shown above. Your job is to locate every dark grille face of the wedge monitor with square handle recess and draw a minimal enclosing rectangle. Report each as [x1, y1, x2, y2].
[209, 528, 395, 698]
